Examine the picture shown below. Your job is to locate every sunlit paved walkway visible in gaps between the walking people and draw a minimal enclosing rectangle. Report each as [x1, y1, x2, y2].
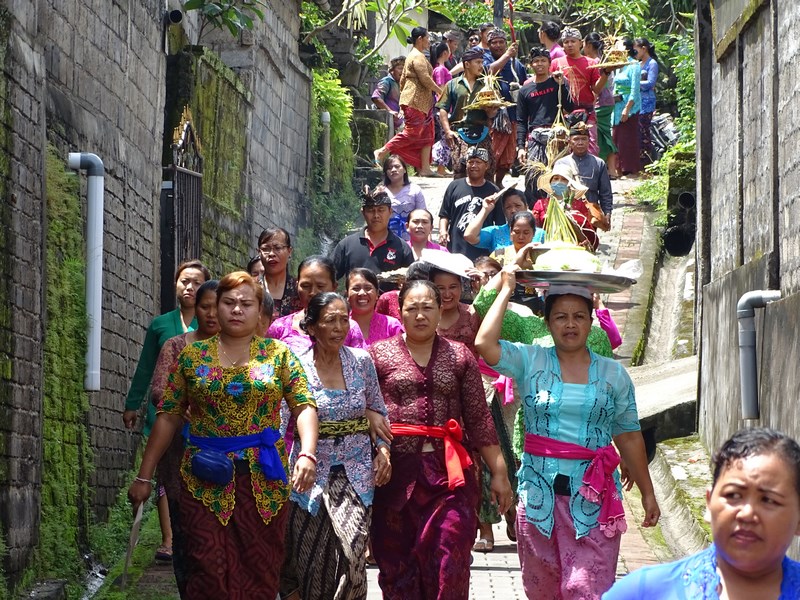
[130, 172, 659, 600]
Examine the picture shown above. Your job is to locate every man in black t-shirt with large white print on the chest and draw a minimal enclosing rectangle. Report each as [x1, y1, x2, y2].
[439, 146, 506, 261]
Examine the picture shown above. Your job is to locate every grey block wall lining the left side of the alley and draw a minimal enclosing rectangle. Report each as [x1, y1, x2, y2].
[0, 0, 311, 584]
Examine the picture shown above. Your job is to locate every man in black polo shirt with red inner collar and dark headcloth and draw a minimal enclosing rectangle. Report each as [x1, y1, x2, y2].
[332, 187, 414, 292]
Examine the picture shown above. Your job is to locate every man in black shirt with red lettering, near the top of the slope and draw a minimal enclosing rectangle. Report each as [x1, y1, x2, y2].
[517, 48, 573, 164]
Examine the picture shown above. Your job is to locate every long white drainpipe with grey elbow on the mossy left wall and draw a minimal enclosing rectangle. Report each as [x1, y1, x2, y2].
[67, 152, 105, 392]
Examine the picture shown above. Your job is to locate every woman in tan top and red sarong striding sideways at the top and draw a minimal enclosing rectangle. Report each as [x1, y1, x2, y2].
[375, 27, 442, 177]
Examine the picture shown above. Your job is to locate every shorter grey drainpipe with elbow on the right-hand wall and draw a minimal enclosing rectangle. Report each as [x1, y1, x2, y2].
[736, 290, 781, 419]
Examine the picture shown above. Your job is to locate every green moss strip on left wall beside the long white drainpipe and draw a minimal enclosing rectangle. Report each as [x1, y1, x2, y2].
[35, 145, 92, 595]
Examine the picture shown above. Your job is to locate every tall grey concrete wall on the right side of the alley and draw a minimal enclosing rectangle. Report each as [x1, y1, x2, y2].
[697, 0, 800, 520]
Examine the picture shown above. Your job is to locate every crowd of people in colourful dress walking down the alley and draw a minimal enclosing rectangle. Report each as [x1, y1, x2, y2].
[123, 16, 800, 600]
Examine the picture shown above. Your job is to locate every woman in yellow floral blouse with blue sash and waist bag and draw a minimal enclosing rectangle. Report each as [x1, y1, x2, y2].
[128, 271, 317, 600]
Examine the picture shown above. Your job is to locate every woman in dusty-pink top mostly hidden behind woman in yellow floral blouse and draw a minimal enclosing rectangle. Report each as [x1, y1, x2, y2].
[151, 279, 219, 597]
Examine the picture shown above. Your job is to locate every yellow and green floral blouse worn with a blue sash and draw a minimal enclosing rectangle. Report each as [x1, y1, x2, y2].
[159, 336, 315, 525]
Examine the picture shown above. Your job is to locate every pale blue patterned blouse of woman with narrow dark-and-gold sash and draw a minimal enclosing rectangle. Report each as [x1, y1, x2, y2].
[290, 347, 386, 515]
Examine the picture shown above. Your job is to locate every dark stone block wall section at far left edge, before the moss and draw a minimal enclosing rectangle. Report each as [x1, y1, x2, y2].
[0, 2, 45, 588]
